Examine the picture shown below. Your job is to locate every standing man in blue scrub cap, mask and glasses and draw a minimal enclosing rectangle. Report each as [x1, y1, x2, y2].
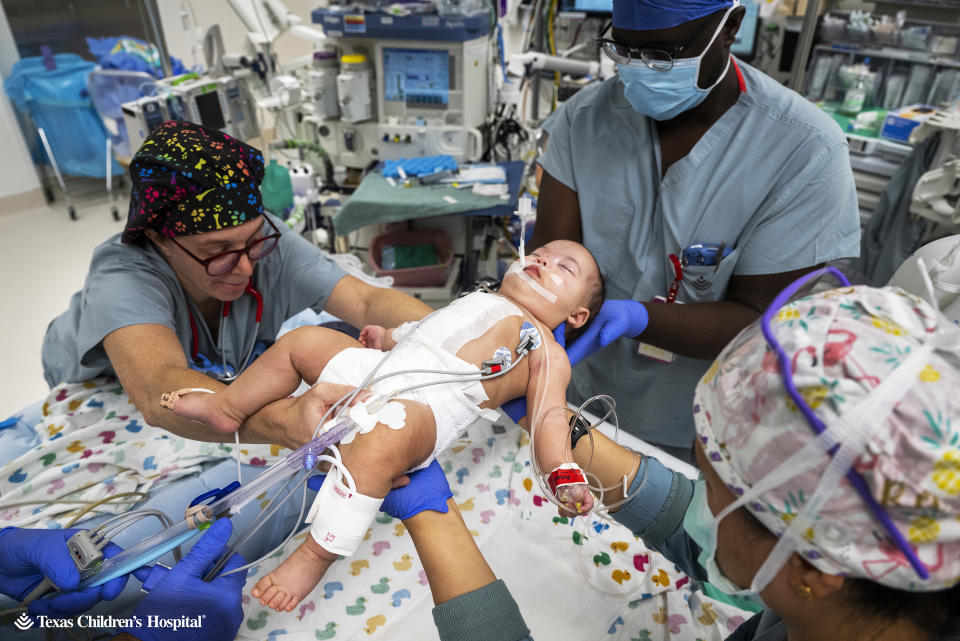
[531, 0, 860, 461]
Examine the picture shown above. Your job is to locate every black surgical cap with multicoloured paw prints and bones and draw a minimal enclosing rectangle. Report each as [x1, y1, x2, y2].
[121, 121, 264, 243]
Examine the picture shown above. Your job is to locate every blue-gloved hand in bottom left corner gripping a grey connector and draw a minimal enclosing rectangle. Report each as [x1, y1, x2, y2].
[0, 527, 127, 618]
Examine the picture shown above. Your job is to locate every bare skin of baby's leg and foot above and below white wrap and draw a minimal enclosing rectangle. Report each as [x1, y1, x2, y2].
[251, 401, 437, 612]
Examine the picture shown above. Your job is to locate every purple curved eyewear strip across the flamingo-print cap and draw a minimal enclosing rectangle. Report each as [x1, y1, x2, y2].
[760, 267, 930, 579]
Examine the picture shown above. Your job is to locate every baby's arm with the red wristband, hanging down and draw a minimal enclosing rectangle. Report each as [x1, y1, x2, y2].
[527, 337, 593, 513]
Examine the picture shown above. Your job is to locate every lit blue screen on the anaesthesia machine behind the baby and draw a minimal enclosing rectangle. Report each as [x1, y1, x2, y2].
[383, 48, 451, 107]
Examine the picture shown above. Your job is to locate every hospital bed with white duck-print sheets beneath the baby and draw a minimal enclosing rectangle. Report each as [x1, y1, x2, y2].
[0, 378, 749, 641]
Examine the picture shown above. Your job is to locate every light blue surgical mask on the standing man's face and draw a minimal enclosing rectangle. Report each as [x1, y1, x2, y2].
[617, 3, 737, 120]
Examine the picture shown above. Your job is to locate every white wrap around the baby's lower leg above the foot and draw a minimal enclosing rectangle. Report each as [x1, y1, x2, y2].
[306, 470, 383, 556]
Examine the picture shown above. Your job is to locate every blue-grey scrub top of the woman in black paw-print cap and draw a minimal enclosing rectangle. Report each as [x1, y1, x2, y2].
[42, 214, 346, 387]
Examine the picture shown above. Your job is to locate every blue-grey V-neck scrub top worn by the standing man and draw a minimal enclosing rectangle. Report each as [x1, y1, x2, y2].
[538, 61, 860, 447]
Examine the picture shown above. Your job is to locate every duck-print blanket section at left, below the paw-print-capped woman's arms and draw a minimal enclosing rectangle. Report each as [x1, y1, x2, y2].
[0, 377, 276, 528]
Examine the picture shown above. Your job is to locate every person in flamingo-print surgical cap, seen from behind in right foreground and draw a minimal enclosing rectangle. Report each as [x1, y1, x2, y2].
[434, 278, 960, 641]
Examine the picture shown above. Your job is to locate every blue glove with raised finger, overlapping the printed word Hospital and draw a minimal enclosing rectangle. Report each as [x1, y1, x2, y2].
[121, 519, 247, 641]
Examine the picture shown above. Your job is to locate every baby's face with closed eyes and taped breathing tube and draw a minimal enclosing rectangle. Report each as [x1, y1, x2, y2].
[500, 240, 600, 329]
